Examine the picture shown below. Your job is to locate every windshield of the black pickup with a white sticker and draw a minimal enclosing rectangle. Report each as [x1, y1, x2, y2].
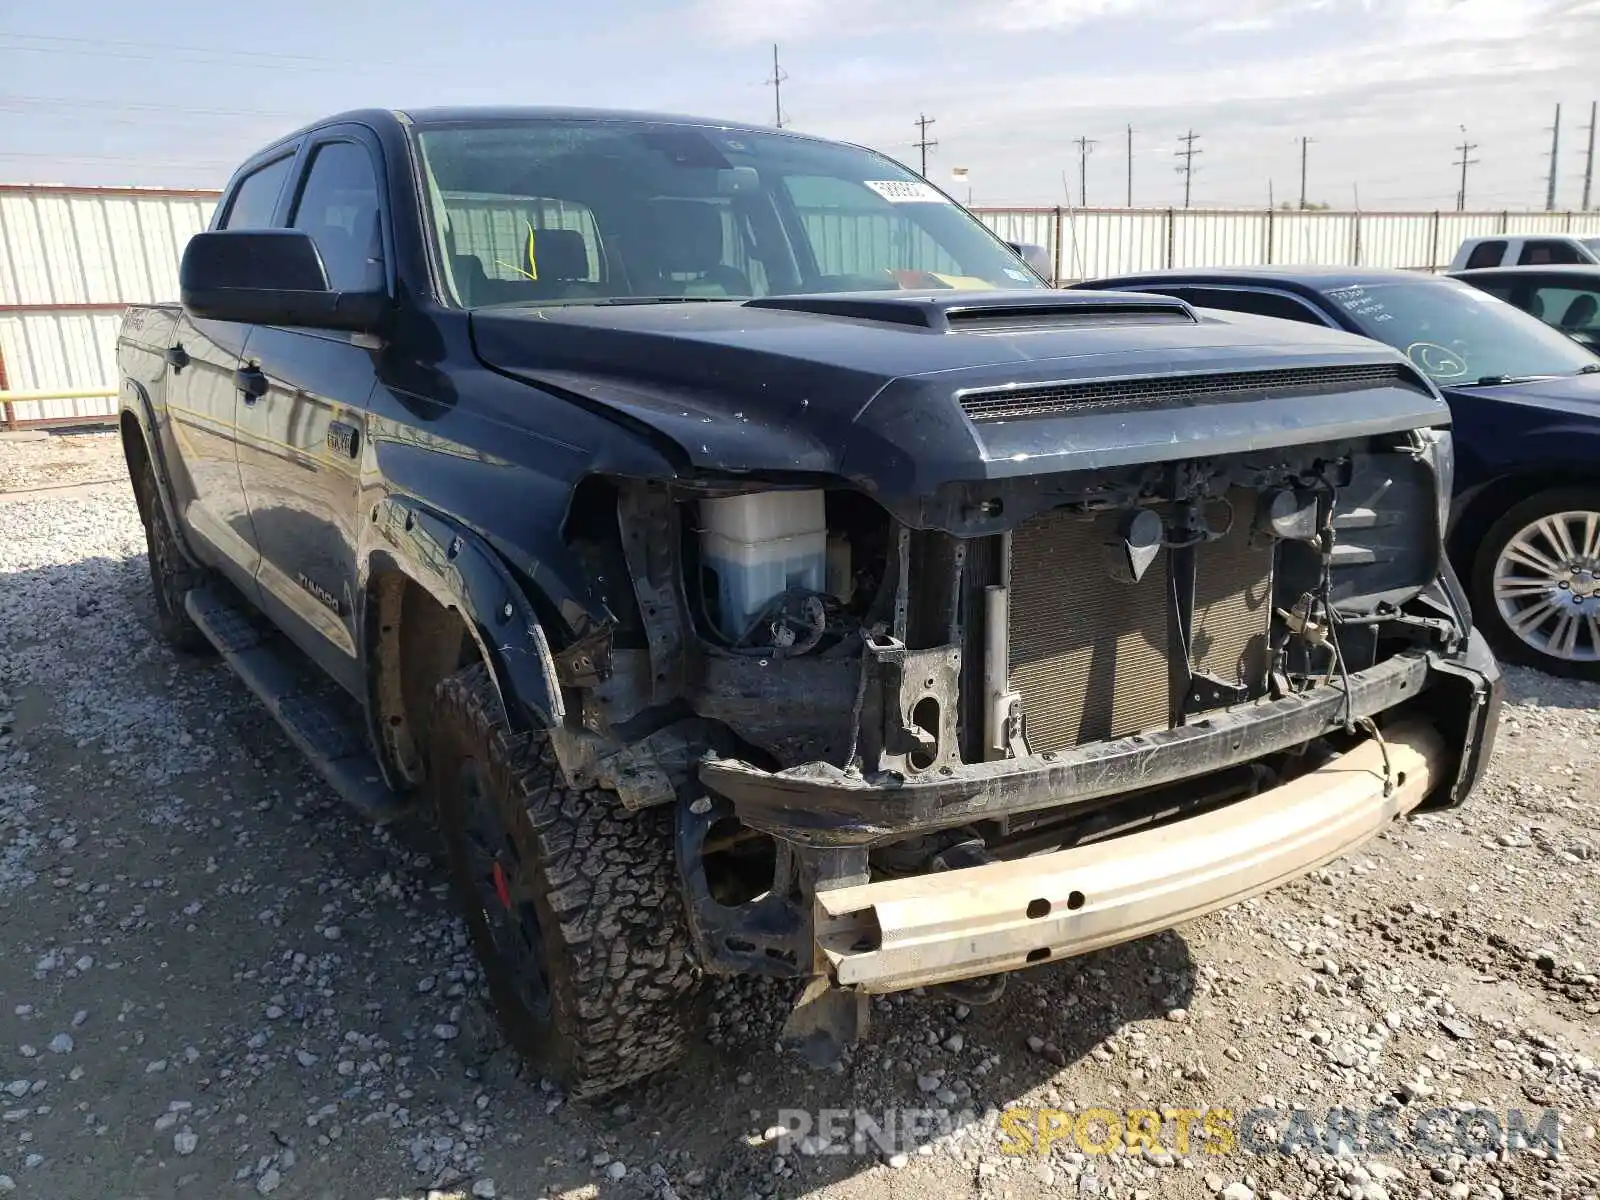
[416, 118, 1043, 307]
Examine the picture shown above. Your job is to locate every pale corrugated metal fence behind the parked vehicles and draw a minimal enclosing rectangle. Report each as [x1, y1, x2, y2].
[9, 184, 1600, 426]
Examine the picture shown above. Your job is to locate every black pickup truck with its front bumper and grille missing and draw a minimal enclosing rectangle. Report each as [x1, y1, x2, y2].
[118, 110, 1499, 1094]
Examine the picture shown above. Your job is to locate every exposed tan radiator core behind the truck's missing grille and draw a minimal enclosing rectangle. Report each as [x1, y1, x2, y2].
[1010, 490, 1272, 754]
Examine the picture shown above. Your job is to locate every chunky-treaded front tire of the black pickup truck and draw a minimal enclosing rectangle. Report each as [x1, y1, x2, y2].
[429, 664, 699, 1096]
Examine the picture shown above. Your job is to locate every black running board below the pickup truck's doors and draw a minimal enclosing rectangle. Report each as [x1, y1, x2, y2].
[184, 587, 410, 824]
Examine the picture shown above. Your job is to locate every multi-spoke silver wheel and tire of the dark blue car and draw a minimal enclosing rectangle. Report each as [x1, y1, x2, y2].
[1472, 488, 1600, 680]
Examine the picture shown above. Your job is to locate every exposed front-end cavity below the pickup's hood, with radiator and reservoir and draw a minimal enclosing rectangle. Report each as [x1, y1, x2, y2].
[558, 430, 1462, 998]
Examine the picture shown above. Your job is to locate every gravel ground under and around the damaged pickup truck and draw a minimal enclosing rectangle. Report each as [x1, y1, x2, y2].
[0, 437, 1600, 1200]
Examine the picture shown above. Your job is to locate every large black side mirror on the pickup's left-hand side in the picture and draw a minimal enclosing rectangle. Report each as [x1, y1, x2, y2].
[178, 229, 389, 333]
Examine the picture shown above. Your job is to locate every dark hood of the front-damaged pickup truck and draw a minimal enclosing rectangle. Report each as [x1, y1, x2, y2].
[470, 291, 1450, 494]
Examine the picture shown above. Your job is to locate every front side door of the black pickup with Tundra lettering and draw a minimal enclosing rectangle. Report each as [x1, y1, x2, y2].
[238, 126, 387, 694]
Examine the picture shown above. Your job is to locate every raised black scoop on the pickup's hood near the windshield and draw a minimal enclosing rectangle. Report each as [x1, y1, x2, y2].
[746, 291, 1198, 333]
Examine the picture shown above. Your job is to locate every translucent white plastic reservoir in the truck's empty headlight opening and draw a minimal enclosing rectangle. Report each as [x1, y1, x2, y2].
[701, 491, 827, 645]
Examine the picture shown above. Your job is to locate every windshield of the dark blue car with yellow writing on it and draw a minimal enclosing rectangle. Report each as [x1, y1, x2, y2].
[1325, 278, 1600, 384]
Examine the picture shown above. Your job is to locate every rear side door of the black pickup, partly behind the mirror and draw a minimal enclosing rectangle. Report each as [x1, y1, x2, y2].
[166, 147, 294, 598]
